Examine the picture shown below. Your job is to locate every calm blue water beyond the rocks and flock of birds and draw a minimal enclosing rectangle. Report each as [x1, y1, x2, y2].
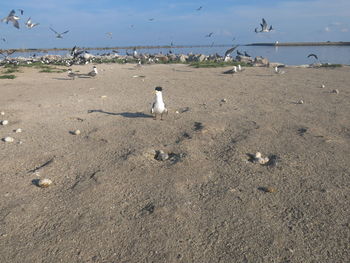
[12, 46, 350, 65]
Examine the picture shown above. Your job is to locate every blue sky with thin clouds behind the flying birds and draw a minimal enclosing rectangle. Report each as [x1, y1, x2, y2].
[0, 0, 350, 49]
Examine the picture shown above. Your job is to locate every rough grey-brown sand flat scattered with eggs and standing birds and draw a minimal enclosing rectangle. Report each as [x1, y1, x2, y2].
[0, 64, 350, 263]
